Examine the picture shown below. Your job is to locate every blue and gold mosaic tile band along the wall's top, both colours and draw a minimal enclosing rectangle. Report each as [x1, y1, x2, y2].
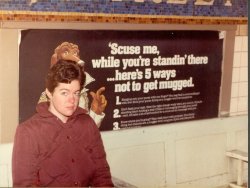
[0, 0, 248, 27]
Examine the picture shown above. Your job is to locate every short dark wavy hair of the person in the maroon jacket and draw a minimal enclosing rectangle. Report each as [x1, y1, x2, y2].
[45, 59, 86, 93]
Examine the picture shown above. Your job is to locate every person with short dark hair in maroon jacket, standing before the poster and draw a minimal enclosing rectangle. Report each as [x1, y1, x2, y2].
[12, 60, 113, 187]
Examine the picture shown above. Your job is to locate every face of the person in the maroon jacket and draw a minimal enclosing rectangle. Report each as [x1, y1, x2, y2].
[46, 80, 80, 123]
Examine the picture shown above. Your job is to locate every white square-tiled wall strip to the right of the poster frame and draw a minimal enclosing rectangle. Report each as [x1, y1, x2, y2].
[230, 26, 248, 116]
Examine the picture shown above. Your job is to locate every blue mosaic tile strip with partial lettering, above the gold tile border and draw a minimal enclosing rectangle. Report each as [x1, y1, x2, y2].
[0, 0, 247, 17]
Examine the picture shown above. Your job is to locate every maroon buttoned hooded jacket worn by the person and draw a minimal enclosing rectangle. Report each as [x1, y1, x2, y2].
[12, 103, 113, 187]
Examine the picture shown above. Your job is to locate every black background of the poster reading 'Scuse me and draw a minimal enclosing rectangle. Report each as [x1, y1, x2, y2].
[19, 29, 223, 130]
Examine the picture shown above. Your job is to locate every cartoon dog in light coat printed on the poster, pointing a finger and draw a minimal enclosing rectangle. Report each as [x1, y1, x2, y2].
[38, 42, 107, 127]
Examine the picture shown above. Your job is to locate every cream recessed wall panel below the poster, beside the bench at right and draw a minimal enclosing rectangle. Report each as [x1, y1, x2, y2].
[176, 134, 227, 183]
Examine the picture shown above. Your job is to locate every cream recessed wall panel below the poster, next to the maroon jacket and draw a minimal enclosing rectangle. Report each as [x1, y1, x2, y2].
[108, 143, 166, 187]
